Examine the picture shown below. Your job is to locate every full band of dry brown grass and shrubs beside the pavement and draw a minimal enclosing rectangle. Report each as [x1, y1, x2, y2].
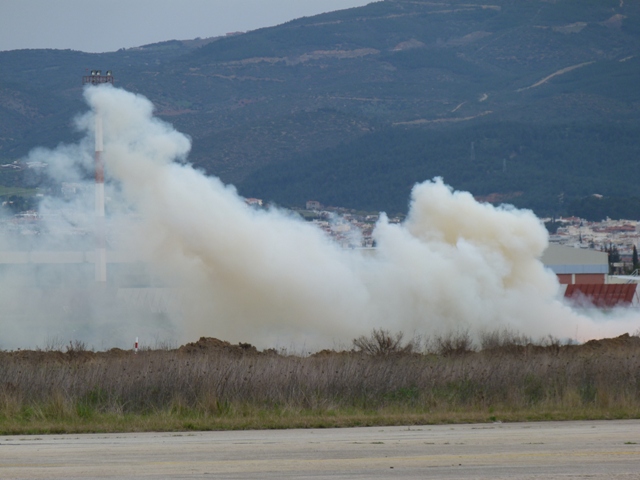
[0, 331, 640, 434]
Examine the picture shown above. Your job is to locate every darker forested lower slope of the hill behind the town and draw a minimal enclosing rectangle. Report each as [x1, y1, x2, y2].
[242, 122, 640, 219]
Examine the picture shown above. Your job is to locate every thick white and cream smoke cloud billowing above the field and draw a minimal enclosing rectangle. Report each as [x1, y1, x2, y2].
[2, 86, 638, 348]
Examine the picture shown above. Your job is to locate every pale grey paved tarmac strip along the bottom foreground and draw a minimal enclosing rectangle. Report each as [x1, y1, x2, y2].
[0, 420, 640, 480]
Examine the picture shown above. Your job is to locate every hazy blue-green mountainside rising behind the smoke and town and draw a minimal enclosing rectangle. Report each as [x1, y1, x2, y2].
[0, 0, 640, 217]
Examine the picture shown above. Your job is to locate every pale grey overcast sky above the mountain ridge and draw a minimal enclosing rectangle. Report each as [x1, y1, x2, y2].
[0, 0, 374, 52]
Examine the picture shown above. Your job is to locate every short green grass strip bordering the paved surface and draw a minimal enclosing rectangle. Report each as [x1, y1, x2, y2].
[0, 406, 640, 435]
